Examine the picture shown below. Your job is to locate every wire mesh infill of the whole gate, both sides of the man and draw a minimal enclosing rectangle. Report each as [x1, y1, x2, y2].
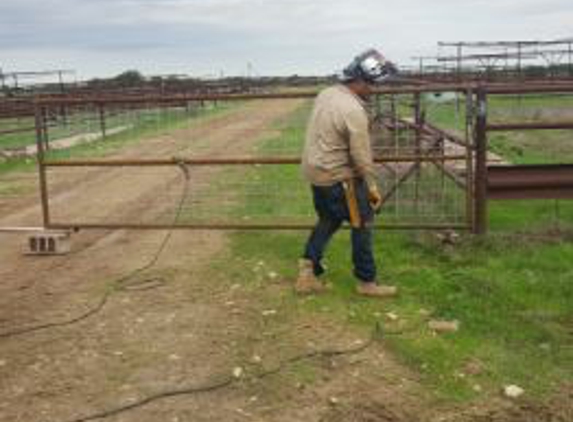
[39, 92, 467, 228]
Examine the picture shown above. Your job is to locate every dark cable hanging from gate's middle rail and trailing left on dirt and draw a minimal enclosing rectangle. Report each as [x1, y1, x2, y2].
[0, 161, 190, 339]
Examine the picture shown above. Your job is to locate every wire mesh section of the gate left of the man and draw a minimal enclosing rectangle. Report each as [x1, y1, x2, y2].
[47, 99, 312, 226]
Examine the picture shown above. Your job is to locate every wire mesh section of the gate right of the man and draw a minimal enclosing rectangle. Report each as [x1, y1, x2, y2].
[373, 93, 471, 225]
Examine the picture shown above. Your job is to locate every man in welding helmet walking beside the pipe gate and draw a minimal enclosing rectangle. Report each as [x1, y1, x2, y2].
[295, 49, 396, 297]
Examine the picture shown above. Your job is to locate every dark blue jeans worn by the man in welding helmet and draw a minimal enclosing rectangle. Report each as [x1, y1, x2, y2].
[303, 179, 376, 282]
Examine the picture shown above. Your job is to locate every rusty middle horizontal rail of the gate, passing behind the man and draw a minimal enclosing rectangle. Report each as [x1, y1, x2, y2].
[42, 154, 467, 167]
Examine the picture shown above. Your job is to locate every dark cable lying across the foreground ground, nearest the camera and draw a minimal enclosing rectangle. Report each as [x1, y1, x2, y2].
[59, 324, 382, 422]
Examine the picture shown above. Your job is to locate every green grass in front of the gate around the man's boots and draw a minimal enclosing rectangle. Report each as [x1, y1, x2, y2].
[227, 232, 573, 400]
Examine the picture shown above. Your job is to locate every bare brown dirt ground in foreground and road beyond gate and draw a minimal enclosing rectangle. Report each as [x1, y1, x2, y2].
[0, 101, 573, 422]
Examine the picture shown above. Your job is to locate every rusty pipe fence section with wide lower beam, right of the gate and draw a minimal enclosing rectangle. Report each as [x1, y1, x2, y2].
[474, 88, 573, 234]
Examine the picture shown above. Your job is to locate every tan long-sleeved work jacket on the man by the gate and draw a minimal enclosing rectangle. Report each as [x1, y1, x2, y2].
[302, 84, 375, 186]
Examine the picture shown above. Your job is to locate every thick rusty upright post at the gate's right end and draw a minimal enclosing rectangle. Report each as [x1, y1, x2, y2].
[473, 87, 488, 235]
